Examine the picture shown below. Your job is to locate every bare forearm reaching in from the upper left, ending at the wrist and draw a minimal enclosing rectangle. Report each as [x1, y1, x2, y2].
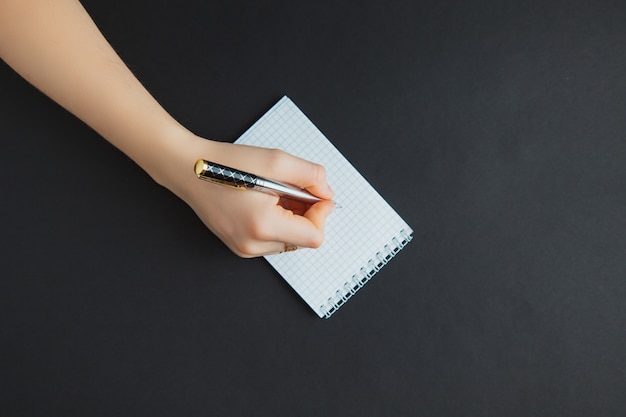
[0, 0, 188, 175]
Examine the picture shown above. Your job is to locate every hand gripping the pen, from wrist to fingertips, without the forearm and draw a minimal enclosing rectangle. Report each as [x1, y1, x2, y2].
[153, 136, 334, 258]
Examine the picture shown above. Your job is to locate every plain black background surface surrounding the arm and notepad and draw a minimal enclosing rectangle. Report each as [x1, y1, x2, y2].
[0, 0, 626, 416]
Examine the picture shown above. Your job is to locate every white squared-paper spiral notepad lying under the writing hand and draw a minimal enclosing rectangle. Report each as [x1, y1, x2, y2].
[235, 96, 413, 318]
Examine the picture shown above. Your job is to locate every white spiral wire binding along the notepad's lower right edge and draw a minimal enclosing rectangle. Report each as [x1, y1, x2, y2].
[320, 229, 413, 319]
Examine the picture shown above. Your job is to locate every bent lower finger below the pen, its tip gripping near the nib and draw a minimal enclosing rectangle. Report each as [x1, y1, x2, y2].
[272, 201, 335, 248]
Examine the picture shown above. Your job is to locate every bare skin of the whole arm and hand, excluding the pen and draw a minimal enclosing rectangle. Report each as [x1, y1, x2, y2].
[0, 0, 334, 258]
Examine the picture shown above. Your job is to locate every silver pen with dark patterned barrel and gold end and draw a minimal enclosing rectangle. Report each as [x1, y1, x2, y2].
[194, 159, 325, 204]
